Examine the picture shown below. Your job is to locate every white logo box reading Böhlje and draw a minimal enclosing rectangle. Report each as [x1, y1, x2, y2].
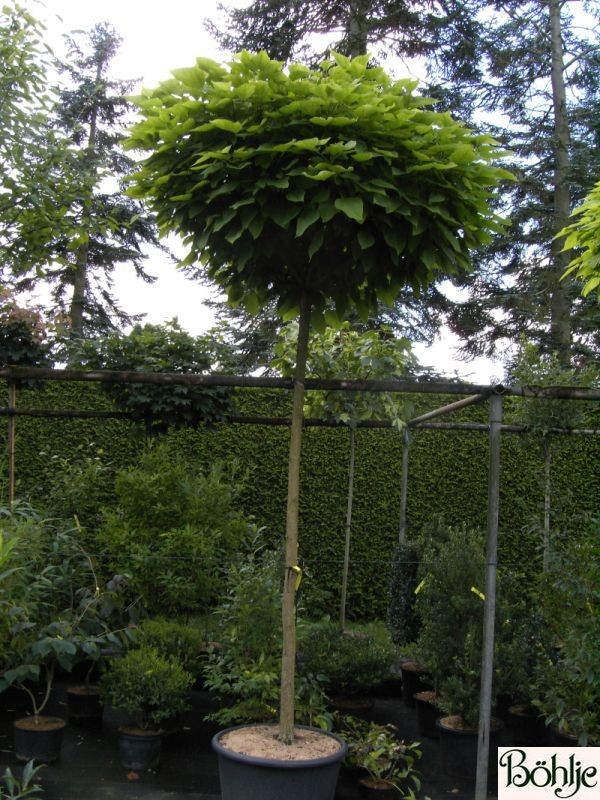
[498, 747, 600, 800]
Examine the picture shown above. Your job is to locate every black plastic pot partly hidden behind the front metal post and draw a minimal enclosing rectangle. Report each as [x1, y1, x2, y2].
[436, 717, 503, 781]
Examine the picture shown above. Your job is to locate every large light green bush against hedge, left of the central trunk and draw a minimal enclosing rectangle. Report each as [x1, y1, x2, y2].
[98, 444, 248, 615]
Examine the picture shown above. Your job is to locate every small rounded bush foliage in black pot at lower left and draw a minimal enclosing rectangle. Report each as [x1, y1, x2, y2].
[100, 647, 194, 730]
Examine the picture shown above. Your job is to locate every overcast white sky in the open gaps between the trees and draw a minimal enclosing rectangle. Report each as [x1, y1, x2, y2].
[37, 0, 502, 383]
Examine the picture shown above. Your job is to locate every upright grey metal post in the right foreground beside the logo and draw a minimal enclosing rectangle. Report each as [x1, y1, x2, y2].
[475, 393, 502, 800]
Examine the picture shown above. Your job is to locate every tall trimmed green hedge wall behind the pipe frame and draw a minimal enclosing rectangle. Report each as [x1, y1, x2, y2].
[0, 382, 600, 618]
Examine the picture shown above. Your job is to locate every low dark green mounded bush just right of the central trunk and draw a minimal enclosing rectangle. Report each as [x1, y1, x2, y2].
[299, 621, 394, 694]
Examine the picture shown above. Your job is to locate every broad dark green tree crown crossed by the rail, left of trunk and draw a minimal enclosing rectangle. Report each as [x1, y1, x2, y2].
[71, 319, 231, 433]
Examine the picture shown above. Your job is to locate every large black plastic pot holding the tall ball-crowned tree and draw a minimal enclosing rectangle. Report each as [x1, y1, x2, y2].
[212, 725, 348, 800]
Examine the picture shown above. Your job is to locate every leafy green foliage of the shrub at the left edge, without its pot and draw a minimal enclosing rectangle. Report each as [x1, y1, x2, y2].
[0, 508, 134, 716]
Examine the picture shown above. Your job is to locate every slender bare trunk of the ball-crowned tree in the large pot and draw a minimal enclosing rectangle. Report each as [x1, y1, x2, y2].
[279, 297, 310, 744]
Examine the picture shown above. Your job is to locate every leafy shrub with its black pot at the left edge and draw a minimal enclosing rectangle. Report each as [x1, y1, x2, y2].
[0, 513, 123, 761]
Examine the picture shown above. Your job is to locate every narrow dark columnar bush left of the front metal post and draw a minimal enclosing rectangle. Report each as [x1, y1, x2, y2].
[388, 543, 419, 646]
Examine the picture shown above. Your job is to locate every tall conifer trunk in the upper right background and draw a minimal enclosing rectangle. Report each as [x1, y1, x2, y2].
[548, 0, 572, 368]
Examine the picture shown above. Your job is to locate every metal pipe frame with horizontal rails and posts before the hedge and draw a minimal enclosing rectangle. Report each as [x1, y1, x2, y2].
[0, 367, 600, 800]
